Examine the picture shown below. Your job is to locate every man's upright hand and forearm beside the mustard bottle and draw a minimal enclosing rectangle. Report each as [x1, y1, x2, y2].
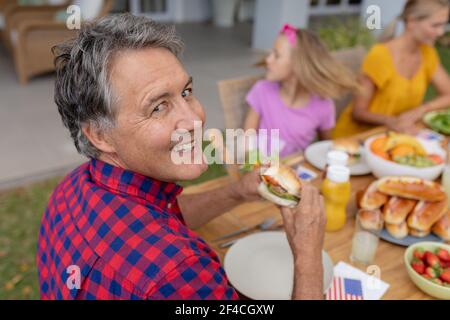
[281, 184, 326, 299]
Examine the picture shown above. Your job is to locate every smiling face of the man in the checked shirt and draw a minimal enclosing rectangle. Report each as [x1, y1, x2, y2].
[108, 48, 207, 181]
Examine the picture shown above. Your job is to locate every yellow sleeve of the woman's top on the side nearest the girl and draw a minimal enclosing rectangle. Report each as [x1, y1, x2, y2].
[362, 44, 392, 88]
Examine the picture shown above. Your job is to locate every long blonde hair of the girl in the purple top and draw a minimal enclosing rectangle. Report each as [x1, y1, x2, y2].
[293, 30, 360, 99]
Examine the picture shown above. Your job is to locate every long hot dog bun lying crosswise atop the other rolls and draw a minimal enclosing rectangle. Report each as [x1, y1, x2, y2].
[378, 177, 446, 202]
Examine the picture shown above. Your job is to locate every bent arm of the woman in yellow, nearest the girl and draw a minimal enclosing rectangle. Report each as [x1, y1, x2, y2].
[352, 75, 395, 127]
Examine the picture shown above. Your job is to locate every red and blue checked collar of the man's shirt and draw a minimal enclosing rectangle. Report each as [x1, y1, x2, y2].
[89, 159, 183, 208]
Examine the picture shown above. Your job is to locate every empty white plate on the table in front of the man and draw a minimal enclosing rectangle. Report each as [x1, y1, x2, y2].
[224, 231, 334, 300]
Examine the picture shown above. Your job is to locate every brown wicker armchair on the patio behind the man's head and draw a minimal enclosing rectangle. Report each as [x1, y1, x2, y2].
[5, 0, 113, 84]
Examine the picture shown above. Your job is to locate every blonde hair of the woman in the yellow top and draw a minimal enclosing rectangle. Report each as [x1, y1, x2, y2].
[378, 0, 450, 42]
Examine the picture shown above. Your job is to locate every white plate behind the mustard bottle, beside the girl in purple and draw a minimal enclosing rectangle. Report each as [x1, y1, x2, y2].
[305, 140, 371, 176]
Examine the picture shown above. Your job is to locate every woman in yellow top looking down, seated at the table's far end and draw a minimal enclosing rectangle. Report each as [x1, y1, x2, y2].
[333, 0, 450, 138]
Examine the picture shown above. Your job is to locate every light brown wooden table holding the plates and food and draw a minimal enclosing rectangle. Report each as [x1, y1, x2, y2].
[184, 128, 432, 300]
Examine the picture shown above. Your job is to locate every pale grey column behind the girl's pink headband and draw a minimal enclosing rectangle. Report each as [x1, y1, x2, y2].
[252, 0, 310, 50]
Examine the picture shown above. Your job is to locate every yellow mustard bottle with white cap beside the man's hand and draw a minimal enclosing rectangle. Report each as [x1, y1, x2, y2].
[321, 166, 351, 231]
